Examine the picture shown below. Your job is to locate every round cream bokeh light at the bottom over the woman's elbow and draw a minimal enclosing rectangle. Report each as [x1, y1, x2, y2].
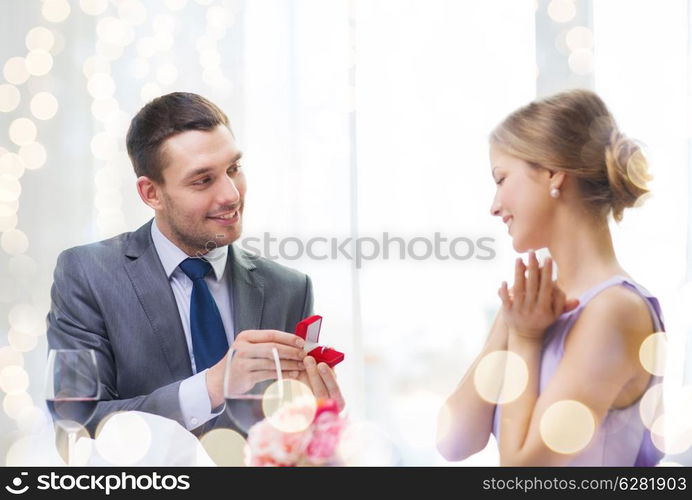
[540, 400, 596, 455]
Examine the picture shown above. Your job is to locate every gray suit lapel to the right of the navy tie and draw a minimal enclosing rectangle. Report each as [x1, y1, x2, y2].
[228, 245, 264, 336]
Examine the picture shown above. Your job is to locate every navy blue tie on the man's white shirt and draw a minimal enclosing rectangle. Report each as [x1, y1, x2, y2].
[180, 258, 228, 373]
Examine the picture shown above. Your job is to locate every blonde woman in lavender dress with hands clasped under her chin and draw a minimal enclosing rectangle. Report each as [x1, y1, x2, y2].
[438, 90, 663, 466]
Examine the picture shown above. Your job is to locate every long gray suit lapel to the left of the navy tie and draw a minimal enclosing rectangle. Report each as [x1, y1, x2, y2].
[125, 221, 192, 380]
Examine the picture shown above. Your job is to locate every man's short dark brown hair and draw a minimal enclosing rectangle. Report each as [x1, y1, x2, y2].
[127, 92, 230, 184]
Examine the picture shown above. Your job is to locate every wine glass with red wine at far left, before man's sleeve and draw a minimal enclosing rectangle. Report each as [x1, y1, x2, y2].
[46, 349, 101, 465]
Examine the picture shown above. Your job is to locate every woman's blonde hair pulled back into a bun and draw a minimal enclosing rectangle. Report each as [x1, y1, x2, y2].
[490, 90, 651, 221]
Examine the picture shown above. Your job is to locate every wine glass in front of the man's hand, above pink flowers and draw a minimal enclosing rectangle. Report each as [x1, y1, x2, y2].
[223, 347, 284, 434]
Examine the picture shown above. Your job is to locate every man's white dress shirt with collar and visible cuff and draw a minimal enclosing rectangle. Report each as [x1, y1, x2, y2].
[151, 219, 233, 430]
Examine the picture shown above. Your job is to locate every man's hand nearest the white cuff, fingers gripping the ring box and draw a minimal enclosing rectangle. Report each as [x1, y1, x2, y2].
[207, 330, 305, 408]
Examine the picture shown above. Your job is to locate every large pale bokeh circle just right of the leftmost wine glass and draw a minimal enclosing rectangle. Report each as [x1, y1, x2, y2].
[95, 412, 152, 465]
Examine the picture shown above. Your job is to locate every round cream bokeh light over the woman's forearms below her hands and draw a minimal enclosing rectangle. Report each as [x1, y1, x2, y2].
[473, 351, 529, 404]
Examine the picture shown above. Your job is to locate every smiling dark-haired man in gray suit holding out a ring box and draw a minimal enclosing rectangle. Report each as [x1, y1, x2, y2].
[48, 92, 344, 435]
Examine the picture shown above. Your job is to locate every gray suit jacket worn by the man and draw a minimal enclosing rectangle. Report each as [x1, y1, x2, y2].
[47, 221, 312, 435]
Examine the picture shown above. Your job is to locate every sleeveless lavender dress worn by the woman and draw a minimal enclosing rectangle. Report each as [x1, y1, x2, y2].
[493, 276, 664, 466]
